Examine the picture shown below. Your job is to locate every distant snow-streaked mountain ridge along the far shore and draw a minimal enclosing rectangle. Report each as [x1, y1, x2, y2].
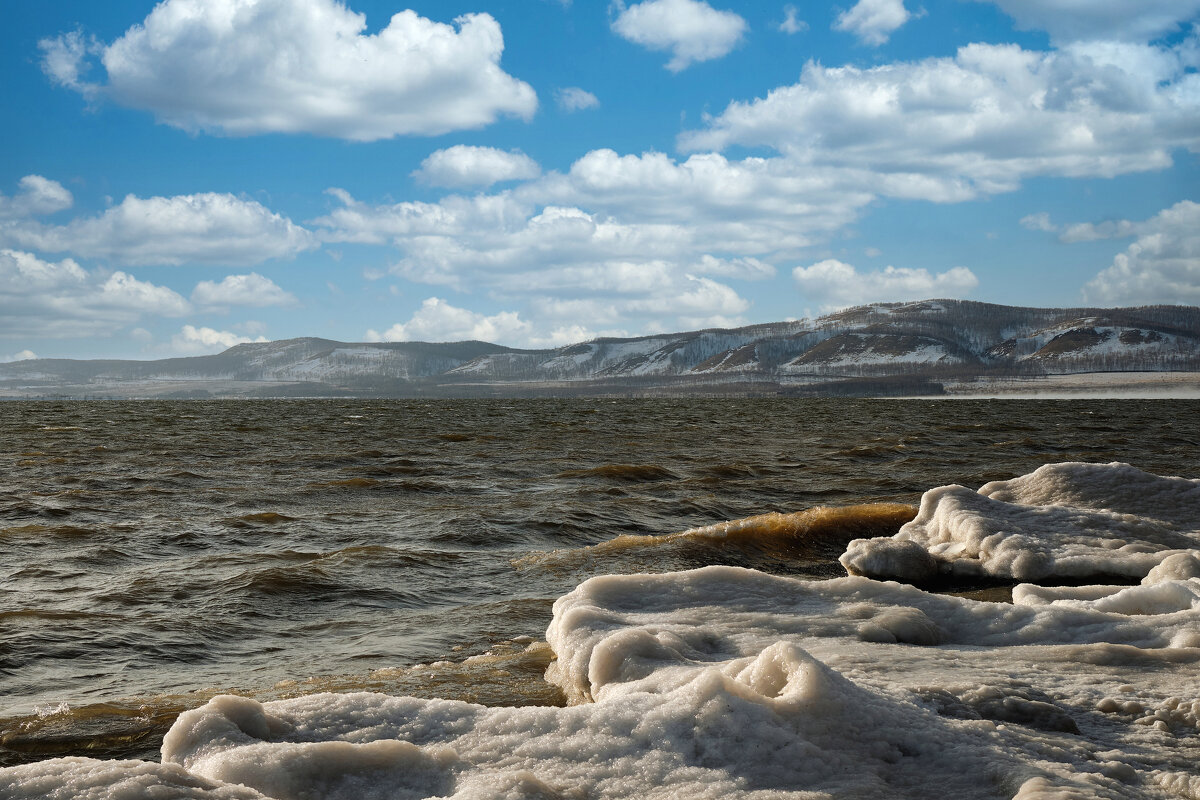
[7, 300, 1200, 397]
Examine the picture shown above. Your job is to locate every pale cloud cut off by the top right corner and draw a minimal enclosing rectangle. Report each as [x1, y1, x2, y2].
[983, 0, 1200, 42]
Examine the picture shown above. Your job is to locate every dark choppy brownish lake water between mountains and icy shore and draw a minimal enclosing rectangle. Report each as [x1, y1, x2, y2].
[0, 399, 1200, 765]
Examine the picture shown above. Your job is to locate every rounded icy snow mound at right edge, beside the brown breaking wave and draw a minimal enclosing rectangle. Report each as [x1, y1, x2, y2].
[841, 463, 1200, 583]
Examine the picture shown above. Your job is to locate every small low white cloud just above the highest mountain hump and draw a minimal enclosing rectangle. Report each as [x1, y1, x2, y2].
[792, 258, 979, 311]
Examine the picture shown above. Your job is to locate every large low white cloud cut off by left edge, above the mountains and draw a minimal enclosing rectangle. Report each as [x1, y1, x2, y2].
[0, 249, 190, 337]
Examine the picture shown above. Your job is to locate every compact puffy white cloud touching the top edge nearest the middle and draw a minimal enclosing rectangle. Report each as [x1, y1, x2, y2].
[612, 0, 749, 72]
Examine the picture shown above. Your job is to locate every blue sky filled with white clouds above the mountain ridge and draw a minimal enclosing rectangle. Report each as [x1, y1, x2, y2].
[0, 0, 1200, 361]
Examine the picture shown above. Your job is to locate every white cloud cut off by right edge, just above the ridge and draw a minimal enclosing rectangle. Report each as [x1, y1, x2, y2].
[1084, 200, 1200, 306]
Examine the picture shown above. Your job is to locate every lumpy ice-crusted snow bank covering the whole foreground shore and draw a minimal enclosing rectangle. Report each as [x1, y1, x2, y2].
[0, 464, 1200, 800]
